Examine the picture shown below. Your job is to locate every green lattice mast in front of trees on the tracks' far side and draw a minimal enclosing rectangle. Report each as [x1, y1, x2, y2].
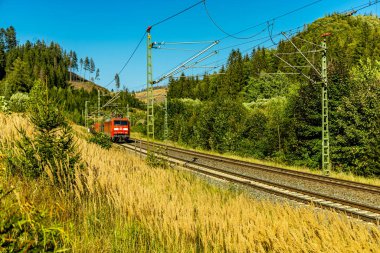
[321, 39, 330, 175]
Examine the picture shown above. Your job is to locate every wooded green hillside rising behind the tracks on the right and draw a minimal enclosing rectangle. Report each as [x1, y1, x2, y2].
[168, 14, 380, 175]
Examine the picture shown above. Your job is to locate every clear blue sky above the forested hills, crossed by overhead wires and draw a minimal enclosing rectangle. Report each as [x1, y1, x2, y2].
[0, 0, 380, 90]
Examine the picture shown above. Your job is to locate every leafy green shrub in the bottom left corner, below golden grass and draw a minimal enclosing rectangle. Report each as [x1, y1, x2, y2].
[0, 187, 69, 252]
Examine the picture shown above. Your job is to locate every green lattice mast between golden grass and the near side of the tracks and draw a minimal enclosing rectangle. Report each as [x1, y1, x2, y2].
[146, 27, 154, 141]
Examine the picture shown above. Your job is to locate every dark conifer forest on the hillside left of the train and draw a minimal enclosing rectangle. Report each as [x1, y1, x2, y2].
[0, 26, 144, 124]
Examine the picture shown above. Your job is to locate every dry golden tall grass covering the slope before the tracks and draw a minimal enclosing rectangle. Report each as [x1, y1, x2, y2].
[0, 114, 380, 252]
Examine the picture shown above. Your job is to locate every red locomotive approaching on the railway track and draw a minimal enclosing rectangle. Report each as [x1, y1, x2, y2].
[92, 118, 131, 142]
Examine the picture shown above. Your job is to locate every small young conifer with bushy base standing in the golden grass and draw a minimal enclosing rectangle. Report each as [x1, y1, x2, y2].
[8, 82, 80, 186]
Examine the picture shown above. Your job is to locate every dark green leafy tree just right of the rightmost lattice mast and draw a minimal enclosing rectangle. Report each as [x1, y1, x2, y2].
[333, 59, 380, 176]
